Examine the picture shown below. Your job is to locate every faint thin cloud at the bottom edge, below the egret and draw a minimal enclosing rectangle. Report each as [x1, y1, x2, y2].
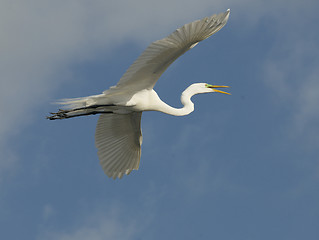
[37, 195, 160, 240]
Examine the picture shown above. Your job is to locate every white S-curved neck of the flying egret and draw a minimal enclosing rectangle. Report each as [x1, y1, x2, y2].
[158, 89, 194, 116]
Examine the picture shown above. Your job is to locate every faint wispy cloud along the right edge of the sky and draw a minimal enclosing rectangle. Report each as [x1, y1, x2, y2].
[264, 1, 319, 142]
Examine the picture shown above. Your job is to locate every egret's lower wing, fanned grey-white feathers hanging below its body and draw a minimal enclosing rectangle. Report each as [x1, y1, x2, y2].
[95, 112, 142, 179]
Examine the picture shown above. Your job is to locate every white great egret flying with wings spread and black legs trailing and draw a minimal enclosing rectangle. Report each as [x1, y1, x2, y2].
[47, 9, 230, 179]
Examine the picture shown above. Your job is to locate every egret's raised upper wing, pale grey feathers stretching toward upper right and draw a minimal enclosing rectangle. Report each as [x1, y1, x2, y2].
[115, 9, 230, 91]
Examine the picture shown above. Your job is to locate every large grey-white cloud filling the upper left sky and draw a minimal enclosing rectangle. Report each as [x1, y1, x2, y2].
[0, 0, 230, 180]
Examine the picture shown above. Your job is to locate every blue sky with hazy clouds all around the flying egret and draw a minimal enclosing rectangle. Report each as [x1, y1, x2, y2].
[0, 0, 319, 240]
